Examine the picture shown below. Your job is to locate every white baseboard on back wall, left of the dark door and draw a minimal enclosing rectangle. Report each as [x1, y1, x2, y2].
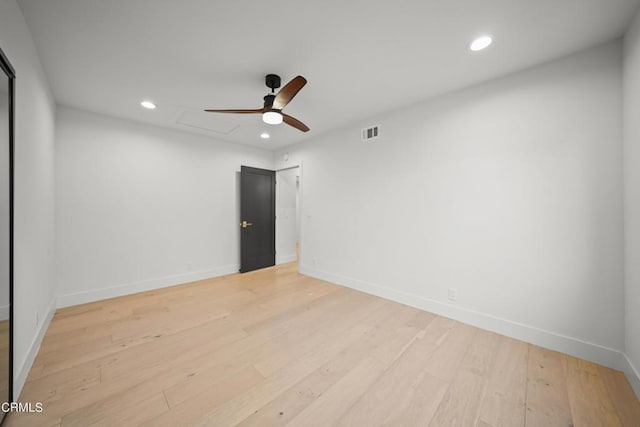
[57, 265, 238, 308]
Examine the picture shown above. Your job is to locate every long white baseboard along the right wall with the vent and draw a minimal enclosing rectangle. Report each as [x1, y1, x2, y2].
[300, 265, 640, 396]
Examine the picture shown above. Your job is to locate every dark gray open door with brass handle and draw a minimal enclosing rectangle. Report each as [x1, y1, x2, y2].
[240, 166, 276, 273]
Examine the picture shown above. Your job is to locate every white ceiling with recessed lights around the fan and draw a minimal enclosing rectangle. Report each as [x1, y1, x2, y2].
[19, 0, 638, 149]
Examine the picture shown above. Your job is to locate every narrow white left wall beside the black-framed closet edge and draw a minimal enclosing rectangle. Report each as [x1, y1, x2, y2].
[0, 0, 55, 397]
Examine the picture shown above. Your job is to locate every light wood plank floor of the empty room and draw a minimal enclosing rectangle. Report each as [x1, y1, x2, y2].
[7, 264, 640, 427]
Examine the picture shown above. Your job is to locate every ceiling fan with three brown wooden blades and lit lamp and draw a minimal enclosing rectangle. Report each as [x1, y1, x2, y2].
[204, 74, 309, 132]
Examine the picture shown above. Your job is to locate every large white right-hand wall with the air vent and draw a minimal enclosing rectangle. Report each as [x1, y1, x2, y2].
[275, 43, 624, 367]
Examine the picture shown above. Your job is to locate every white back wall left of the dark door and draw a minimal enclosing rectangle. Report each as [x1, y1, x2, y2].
[56, 107, 273, 306]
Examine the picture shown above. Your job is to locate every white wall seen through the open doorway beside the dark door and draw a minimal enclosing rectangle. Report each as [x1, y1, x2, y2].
[276, 167, 300, 264]
